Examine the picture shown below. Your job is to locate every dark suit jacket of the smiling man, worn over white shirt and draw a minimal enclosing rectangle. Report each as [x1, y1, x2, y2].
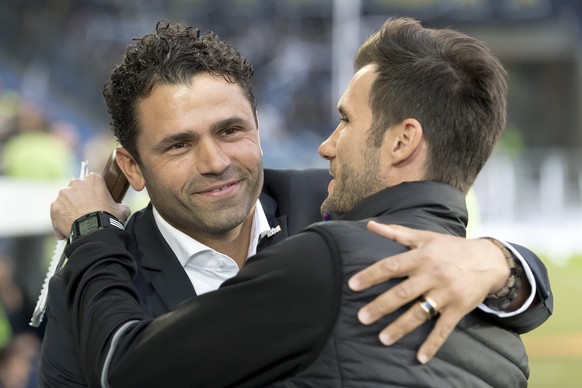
[40, 169, 329, 388]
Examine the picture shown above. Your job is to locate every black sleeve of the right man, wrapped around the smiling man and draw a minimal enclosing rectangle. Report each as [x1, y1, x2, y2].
[65, 230, 341, 388]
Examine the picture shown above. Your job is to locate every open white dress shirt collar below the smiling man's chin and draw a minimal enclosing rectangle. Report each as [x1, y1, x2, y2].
[153, 200, 271, 295]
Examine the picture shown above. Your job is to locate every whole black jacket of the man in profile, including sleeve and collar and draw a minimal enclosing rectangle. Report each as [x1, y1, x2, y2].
[64, 182, 551, 388]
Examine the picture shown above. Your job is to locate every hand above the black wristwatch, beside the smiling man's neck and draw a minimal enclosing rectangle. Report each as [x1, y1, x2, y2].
[51, 173, 130, 240]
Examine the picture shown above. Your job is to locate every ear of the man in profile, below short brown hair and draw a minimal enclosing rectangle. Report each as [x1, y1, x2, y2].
[385, 118, 423, 165]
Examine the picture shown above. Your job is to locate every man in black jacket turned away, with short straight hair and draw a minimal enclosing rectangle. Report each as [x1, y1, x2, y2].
[52, 19, 551, 387]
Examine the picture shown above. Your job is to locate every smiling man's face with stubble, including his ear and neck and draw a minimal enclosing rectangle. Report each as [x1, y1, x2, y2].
[117, 73, 268, 267]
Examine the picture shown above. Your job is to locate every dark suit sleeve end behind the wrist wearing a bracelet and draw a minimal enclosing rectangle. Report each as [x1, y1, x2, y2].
[493, 243, 554, 334]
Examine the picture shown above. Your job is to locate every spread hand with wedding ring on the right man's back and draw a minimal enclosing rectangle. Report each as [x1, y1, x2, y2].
[349, 221, 509, 364]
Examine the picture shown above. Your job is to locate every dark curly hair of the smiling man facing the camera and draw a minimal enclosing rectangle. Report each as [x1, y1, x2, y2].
[103, 21, 257, 163]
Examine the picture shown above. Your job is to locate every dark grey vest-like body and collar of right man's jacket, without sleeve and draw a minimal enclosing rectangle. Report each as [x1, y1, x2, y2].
[274, 182, 529, 388]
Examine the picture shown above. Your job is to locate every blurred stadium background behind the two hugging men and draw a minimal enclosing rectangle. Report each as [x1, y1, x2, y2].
[0, 0, 582, 387]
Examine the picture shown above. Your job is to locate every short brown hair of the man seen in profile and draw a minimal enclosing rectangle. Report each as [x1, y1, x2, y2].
[354, 18, 507, 192]
